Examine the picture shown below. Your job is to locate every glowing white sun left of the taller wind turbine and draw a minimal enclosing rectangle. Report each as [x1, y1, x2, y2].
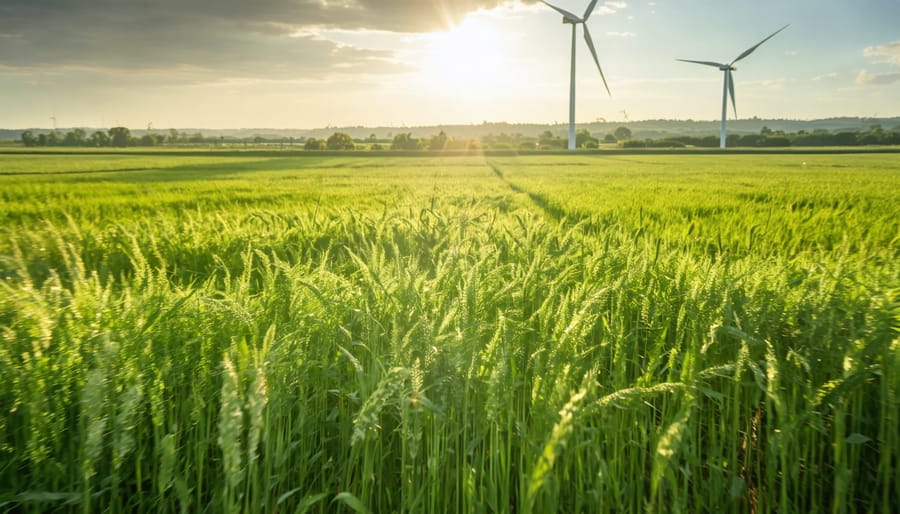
[421, 17, 512, 98]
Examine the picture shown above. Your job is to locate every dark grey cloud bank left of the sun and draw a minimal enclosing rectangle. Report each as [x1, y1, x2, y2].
[0, 0, 534, 78]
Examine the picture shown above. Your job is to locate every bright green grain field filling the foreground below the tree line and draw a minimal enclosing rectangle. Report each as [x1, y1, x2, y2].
[0, 153, 900, 514]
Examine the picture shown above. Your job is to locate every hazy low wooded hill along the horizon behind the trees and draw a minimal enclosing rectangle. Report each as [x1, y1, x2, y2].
[0, 117, 900, 141]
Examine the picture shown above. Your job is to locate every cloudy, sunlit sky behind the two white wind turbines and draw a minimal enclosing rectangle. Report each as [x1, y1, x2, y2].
[0, 0, 900, 129]
